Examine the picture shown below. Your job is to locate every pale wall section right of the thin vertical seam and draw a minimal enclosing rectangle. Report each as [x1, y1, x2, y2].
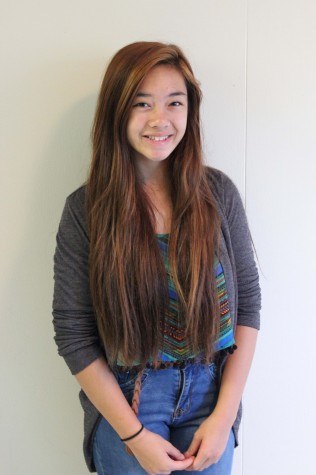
[243, 0, 316, 475]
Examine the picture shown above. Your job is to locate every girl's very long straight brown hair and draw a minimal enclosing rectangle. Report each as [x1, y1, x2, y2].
[87, 42, 219, 366]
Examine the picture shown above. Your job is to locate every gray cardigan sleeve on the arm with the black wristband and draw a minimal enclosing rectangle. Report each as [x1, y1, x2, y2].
[53, 187, 103, 374]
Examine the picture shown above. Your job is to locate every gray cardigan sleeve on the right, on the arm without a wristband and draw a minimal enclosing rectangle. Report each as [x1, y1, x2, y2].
[208, 169, 261, 330]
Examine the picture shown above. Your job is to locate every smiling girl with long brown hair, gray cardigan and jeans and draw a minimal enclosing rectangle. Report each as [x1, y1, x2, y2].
[53, 42, 260, 475]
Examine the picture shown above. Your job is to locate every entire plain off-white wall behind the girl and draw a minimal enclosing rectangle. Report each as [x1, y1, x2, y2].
[0, 0, 316, 475]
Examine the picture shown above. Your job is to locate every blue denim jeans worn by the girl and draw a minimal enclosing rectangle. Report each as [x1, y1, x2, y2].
[93, 363, 235, 475]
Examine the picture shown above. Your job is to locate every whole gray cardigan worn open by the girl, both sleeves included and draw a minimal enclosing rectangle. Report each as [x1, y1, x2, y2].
[53, 168, 261, 472]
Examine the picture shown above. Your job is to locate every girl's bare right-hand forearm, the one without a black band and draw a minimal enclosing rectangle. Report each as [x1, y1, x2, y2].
[213, 325, 258, 427]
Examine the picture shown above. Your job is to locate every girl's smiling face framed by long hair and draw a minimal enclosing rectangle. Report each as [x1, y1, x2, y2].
[127, 64, 188, 170]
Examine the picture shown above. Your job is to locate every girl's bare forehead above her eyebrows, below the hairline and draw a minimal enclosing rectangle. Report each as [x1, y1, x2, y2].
[138, 64, 187, 94]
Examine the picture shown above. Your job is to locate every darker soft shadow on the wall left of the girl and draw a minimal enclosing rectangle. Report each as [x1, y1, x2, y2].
[28, 94, 97, 374]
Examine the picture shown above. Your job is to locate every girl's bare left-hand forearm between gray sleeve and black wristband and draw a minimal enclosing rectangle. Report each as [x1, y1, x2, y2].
[76, 358, 140, 438]
